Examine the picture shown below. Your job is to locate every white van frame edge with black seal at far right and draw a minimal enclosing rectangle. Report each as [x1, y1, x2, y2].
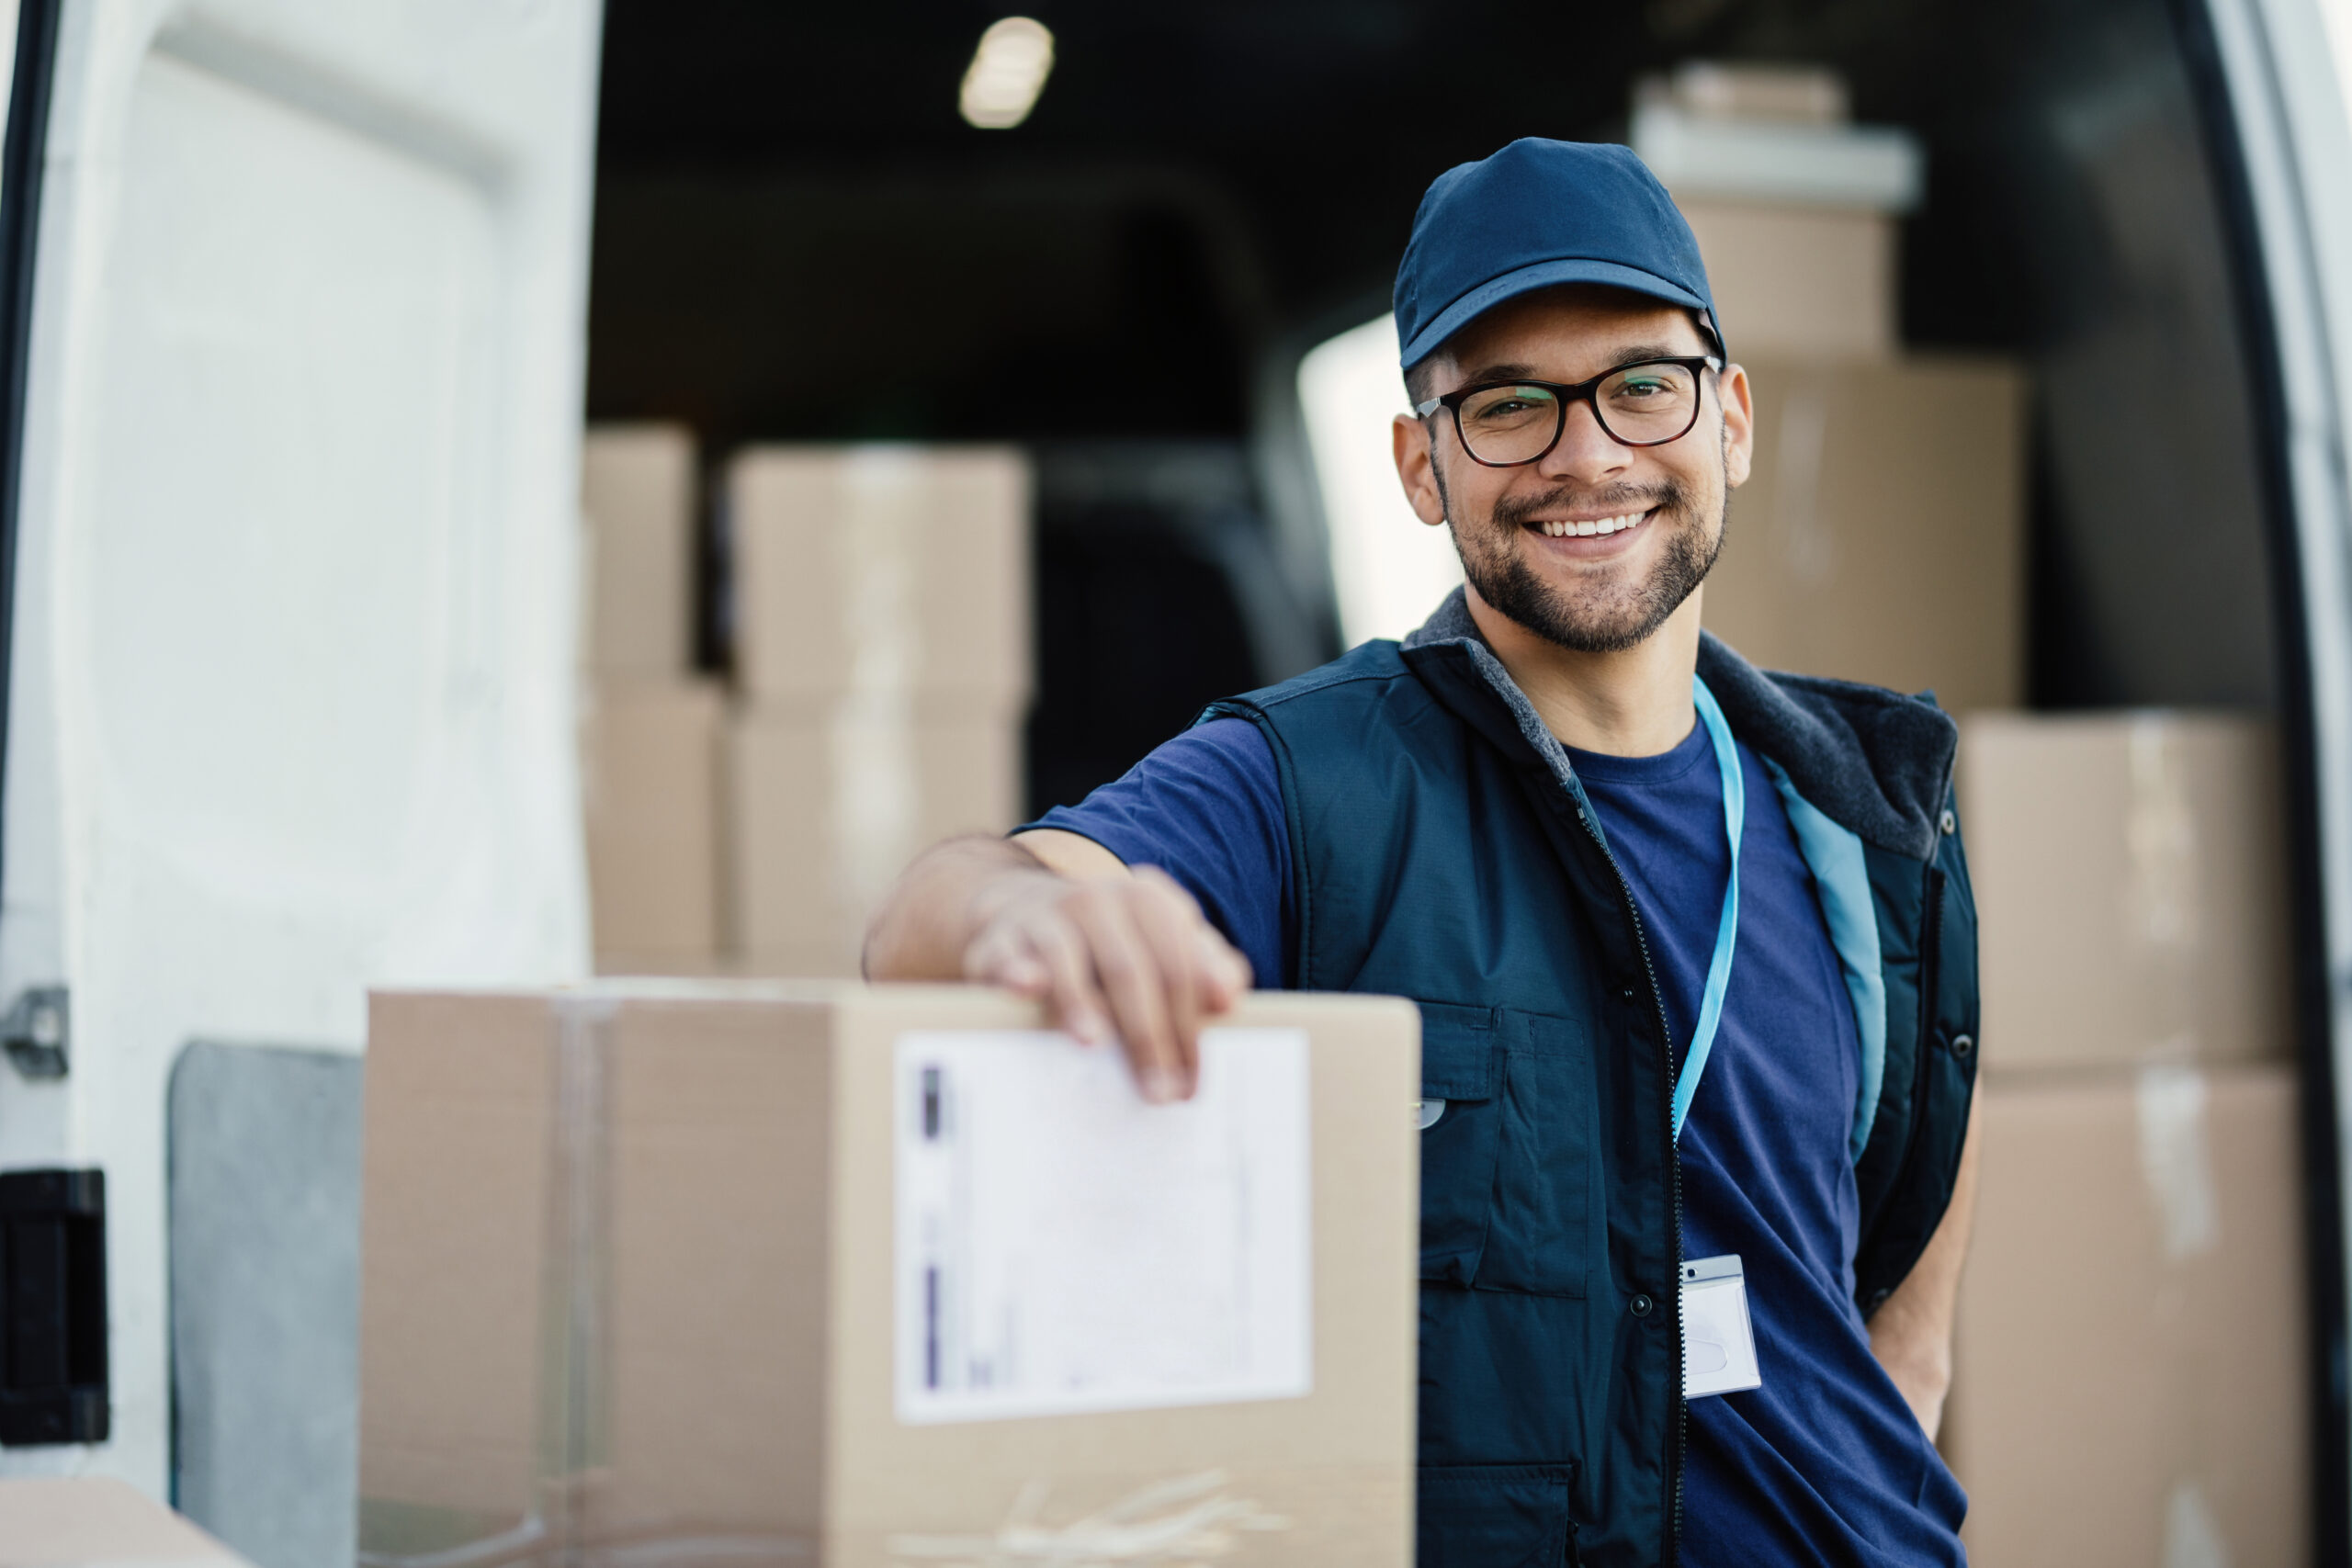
[2192, 0, 2352, 1563]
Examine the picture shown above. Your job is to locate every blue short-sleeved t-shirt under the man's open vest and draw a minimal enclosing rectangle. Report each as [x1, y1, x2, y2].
[1033, 719, 1966, 1568]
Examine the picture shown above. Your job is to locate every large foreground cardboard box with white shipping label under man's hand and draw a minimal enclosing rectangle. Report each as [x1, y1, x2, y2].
[360, 980, 1419, 1568]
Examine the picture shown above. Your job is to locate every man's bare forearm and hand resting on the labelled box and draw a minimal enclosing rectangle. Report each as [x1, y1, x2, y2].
[865, 828, 1249, 1100]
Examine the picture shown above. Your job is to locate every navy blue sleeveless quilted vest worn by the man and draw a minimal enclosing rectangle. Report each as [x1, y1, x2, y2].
[1204, 597, 1975, 1568]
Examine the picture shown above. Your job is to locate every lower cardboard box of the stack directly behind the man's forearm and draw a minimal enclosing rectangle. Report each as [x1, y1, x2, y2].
[727, 698, 1023, 976]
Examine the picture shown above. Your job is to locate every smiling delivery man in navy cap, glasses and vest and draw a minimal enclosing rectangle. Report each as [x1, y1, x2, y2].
[868, 141, 1975, 1568]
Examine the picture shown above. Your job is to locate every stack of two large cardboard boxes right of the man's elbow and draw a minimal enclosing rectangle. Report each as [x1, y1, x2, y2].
[1943, 712, 2310, 1568]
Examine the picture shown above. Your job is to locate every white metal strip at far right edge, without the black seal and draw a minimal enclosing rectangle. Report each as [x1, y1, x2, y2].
[2209, 0, 2352, 1532]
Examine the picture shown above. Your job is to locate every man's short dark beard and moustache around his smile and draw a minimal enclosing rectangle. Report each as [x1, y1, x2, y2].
[1437, 475, 1724, 653]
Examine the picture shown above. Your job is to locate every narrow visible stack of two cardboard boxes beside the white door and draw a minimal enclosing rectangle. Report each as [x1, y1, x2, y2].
[581, 425, 724, 974]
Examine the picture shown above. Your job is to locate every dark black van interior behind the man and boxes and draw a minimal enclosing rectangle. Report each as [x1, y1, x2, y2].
[588, 0, 2314, 1561]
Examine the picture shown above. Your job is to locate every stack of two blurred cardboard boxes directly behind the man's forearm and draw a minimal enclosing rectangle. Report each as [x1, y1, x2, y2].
[727, 446, 1030, 976]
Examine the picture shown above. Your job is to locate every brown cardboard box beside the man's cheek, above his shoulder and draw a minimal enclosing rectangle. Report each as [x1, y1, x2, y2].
[1705, 355, 2025, 712]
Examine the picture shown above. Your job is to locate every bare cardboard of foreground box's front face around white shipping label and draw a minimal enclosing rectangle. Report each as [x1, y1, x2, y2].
[826, 992, 1420, 1568]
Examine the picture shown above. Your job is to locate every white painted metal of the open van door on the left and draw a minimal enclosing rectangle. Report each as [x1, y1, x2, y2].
[0, 0, 600, 1493]
